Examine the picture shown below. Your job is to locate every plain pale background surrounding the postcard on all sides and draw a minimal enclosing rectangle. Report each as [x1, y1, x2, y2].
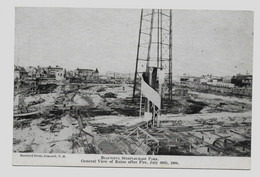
[0, 0, 260, 177]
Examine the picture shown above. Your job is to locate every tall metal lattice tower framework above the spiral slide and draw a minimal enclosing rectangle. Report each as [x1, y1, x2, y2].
[133, 9, 172, 100]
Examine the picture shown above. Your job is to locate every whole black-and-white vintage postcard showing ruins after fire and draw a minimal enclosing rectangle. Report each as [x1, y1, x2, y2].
[13, 7, 254, 169]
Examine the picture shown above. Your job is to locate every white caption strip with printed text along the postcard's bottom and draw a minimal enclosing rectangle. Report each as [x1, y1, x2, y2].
[13, 153, 251, 170]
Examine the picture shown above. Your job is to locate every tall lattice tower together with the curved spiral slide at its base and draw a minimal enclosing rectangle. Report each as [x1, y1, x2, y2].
[133, 9, 172, 127]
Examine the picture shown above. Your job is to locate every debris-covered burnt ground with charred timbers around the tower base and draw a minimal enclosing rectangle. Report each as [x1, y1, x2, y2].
[13, 84, 251, 156]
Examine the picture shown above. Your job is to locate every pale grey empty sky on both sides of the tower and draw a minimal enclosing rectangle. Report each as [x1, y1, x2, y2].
[14, 7, 253, 76]
